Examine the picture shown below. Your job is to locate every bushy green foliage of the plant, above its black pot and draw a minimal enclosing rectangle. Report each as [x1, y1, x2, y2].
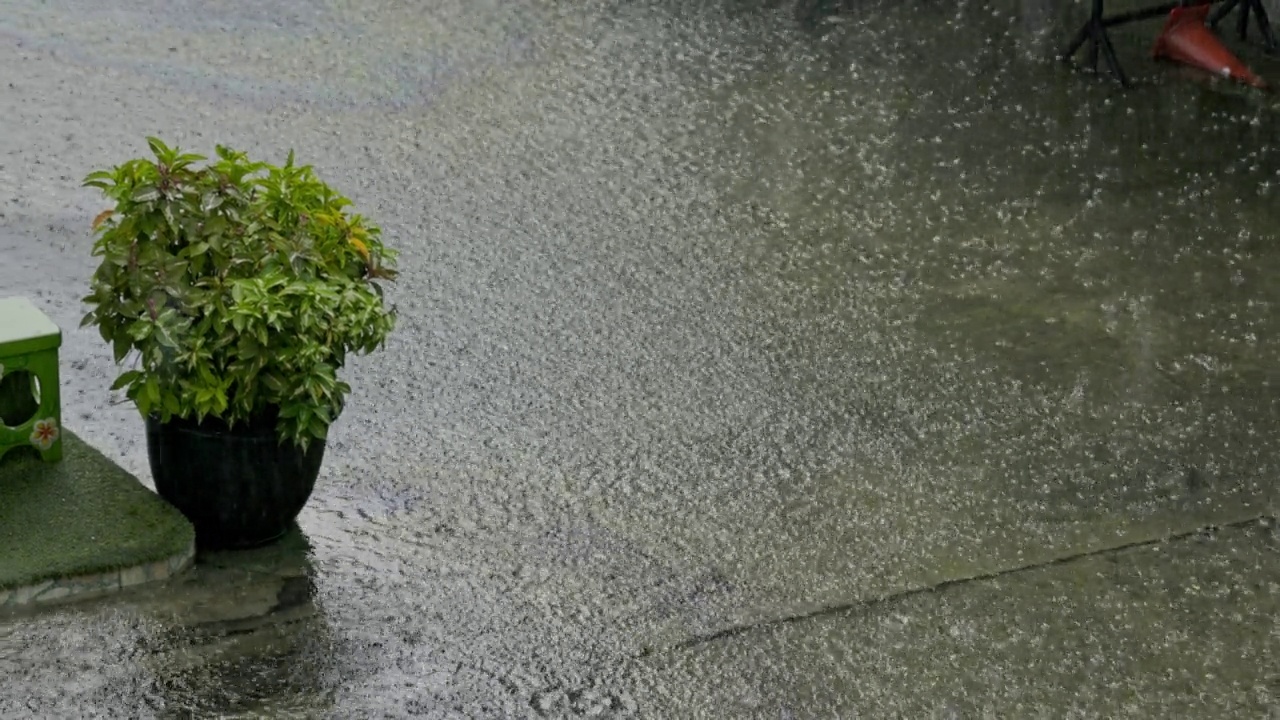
[82, 138, 396, 448]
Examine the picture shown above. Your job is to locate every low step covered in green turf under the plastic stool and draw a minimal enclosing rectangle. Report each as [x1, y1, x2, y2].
[0, 428, 196, 609]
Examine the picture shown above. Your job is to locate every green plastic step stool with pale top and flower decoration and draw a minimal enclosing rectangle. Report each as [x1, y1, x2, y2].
[0, 297, 63, 462]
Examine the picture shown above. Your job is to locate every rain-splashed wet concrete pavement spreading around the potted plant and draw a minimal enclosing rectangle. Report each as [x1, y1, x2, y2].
[0, 0, 1280, 717]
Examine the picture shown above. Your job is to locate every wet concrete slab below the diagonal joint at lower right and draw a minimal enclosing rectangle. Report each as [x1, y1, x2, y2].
[611, 519, 1280, 719]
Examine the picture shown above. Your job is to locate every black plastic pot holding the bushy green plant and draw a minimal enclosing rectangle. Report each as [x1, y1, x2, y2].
[146, 416, 324, 550]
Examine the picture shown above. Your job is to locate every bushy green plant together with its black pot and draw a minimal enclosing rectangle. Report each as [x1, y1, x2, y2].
[82, 138, 396, 548]
